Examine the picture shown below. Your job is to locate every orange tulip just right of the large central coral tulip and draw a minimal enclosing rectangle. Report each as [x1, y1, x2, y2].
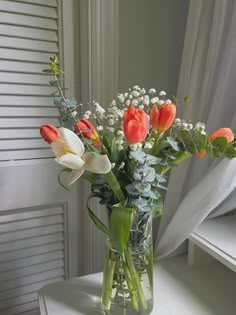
[150, 103, 176, 132]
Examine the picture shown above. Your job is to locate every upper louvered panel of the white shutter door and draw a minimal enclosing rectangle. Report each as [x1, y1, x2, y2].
[0, 0, 60, 161]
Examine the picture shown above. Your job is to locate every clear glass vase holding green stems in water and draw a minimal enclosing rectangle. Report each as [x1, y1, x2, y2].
[102, 213, 153, 315]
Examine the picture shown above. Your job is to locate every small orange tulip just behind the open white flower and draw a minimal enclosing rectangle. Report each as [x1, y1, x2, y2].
[75, 119, 101, 147]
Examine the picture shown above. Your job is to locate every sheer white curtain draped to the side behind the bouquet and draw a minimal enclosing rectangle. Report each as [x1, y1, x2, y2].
[155, 0, 236, 259]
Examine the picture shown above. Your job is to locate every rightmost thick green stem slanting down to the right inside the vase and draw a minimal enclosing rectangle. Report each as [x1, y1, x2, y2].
[125, 247, 147, 310]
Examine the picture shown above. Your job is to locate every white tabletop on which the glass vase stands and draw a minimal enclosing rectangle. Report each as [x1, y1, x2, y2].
[39, 255, 236, 315]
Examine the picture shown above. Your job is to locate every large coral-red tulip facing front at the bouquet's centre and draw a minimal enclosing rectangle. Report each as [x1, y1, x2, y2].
[123, 105, 150, 144]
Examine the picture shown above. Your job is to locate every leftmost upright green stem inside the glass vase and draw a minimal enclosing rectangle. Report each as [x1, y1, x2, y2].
[102, 246, 116, 311]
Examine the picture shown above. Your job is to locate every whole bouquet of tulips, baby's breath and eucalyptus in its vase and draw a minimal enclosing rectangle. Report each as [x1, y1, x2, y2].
[40, 57, 236, 314]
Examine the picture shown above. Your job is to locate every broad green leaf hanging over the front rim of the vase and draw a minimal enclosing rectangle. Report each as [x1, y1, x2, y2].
[110, 202, 135, 256]
